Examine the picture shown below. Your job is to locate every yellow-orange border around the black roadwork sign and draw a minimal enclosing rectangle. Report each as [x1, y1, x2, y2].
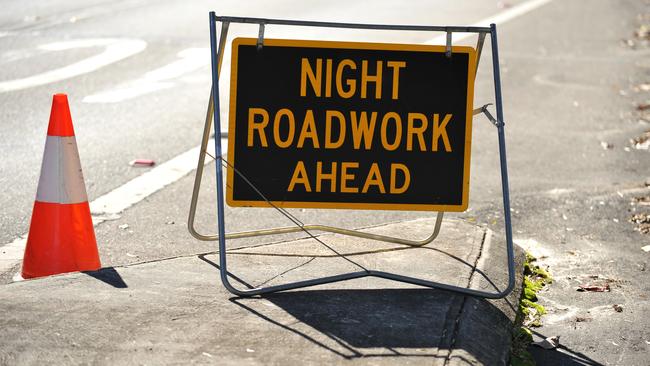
[225, 37, 476, 212]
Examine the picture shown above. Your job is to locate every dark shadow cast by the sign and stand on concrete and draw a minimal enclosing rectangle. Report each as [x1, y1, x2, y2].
[198, 244, 512, 365]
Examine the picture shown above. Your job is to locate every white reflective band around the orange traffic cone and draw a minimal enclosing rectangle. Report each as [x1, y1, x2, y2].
[36, 136, 88, 203]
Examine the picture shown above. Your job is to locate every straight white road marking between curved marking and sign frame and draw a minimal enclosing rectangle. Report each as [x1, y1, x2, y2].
[83, 48, 210, 103]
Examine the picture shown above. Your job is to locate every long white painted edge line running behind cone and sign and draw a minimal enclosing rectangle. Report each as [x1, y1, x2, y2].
[0, 0, 551, 273]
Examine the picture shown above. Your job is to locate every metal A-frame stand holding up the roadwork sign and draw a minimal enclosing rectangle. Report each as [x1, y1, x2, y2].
[188, 12, 515, 299]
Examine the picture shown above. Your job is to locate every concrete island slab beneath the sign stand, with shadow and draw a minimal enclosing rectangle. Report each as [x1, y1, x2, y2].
[0, 219, 523, 365]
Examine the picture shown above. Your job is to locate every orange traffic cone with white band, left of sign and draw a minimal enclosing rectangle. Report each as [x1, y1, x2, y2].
[22, 94, 101, 278]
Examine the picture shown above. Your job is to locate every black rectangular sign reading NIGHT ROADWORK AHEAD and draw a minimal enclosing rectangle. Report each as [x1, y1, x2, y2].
[226, 38, 476, 211]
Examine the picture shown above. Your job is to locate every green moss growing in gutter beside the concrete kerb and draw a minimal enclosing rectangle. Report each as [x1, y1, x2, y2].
[510, 253, 553, 366]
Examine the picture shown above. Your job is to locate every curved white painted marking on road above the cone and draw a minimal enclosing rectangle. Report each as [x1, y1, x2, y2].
[0, 38, 147, 93]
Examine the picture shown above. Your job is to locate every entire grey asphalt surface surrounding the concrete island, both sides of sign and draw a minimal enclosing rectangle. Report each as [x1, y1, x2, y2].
[0, 0, 650, 365]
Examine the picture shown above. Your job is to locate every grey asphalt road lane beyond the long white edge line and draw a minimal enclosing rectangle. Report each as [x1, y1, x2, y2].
[0, 1, 500, 243]
